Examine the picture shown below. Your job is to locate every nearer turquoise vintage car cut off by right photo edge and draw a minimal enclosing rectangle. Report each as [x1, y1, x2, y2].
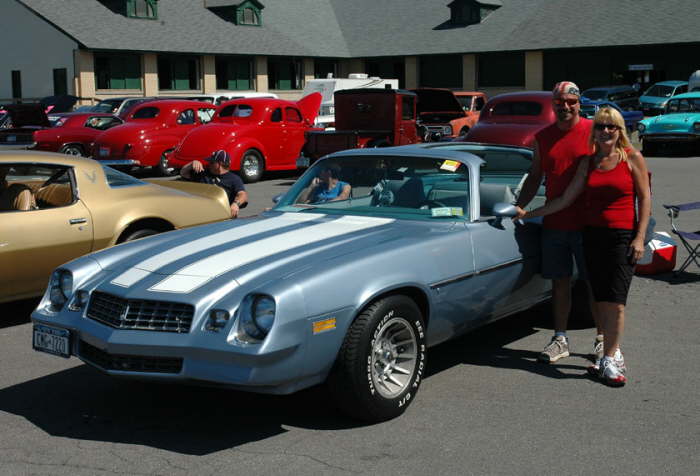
[637, 92, 700, 155]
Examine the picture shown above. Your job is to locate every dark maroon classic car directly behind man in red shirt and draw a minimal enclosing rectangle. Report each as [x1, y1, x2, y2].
[465, 91, 555, 148]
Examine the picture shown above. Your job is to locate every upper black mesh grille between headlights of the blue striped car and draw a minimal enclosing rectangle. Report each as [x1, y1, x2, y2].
[87, 292, 194, 333]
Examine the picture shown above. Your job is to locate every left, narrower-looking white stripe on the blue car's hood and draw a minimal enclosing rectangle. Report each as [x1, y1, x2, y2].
[112, 213, 325, 288]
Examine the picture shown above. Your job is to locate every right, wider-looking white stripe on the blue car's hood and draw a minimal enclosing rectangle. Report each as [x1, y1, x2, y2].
[149, 217, 394, 293]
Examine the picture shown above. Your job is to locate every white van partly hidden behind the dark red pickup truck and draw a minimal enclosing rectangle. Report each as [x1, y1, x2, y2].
[301, 73, 399, 129]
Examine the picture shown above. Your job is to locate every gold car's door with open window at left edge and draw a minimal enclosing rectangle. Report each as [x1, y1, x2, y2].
[0, 165, 93, 298]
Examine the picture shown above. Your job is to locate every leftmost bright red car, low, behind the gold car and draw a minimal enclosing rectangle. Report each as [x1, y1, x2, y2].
[34, 112, 124, 157]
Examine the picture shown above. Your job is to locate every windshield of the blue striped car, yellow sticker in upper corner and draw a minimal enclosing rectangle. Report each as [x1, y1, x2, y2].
[274, 155, 469, 220]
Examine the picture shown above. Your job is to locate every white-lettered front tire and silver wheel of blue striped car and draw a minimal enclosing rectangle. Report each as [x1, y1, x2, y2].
[327, 295, 426, 422]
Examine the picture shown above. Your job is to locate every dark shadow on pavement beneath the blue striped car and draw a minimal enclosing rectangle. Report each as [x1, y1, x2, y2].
[0, 303, 592, 455]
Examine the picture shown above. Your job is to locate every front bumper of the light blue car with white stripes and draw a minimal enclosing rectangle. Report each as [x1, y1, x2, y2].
[32, 309, 312, 394]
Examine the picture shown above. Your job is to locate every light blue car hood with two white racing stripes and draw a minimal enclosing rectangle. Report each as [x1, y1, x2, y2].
[90, 212, 444, 297]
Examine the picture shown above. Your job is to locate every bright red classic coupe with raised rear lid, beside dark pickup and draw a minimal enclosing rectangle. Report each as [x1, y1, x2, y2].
[169, 93, 321, 182]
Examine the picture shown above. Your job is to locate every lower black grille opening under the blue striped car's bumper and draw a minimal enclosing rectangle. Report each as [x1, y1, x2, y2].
[78, 340, 182, 374]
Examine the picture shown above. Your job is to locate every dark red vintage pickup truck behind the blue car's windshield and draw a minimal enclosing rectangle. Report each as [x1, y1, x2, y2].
[297, 88, 421, 167]
